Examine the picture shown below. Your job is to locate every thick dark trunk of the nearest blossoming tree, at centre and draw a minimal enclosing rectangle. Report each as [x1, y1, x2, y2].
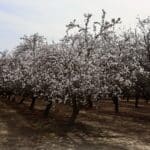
[69, 96, 80, 125]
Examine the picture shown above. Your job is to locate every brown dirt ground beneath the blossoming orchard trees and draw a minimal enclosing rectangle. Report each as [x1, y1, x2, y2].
[0, 98, 150, 150]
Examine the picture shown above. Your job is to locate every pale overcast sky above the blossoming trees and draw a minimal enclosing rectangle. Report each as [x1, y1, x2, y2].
[0, 0, 150, 50]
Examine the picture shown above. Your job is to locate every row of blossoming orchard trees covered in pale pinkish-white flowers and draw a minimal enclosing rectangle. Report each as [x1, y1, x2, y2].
[0, 10, 150, 123]
